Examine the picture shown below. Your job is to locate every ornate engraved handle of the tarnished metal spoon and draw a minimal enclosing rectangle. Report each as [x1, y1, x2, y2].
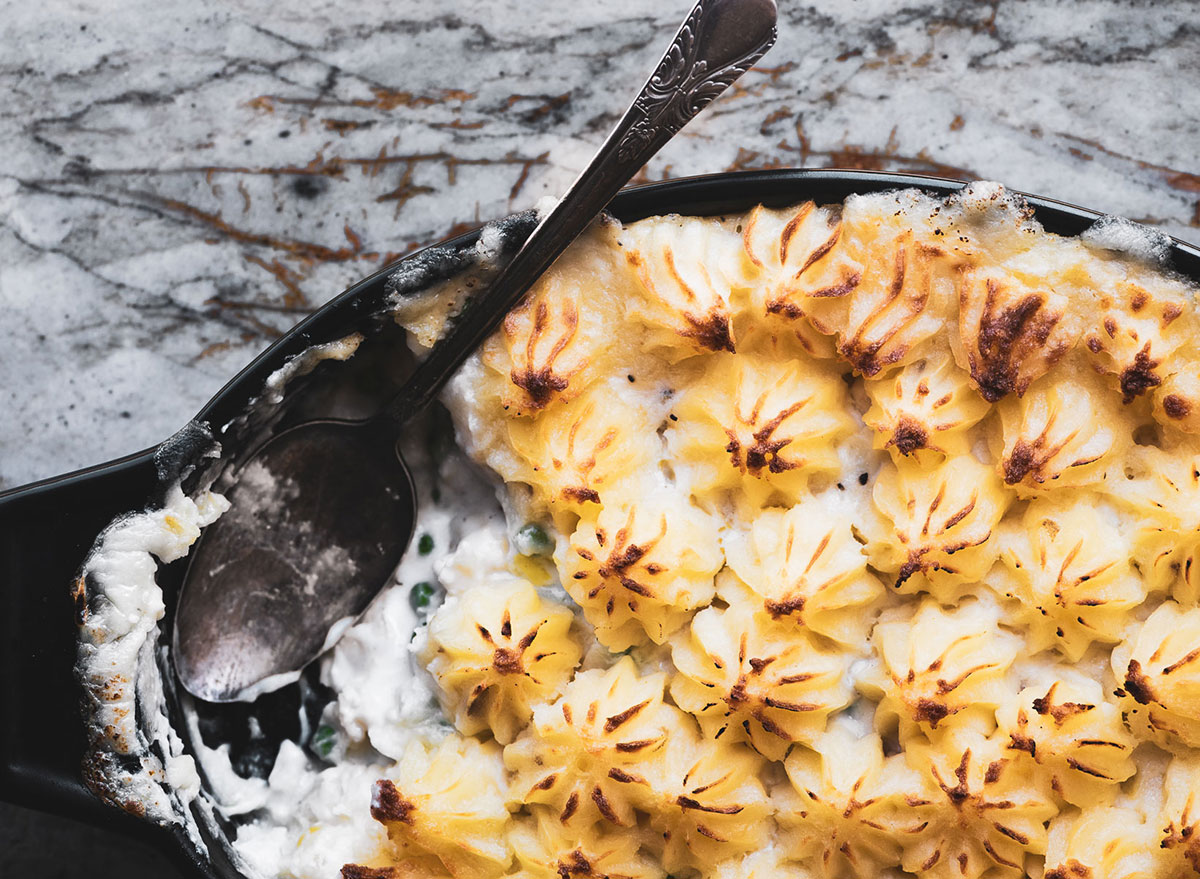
[386, 0, 776, 423]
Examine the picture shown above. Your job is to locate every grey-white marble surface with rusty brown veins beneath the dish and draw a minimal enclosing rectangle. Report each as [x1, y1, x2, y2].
[0, 0, 1200, 877]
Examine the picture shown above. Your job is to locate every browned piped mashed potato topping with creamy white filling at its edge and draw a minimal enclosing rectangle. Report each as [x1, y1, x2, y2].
[182, 184, 1200, 879]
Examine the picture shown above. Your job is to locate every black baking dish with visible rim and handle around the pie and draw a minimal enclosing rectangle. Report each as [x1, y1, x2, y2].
[0, 171, 1200, 877]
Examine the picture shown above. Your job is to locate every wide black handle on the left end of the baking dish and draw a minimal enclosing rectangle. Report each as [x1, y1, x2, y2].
[0, 449, 160, 825]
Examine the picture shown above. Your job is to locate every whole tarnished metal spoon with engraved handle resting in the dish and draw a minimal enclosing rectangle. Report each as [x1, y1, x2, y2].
[173, 0, 776, 701]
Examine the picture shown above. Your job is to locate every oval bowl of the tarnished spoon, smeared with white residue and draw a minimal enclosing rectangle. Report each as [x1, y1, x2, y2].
[174, 419, 416, 702]
